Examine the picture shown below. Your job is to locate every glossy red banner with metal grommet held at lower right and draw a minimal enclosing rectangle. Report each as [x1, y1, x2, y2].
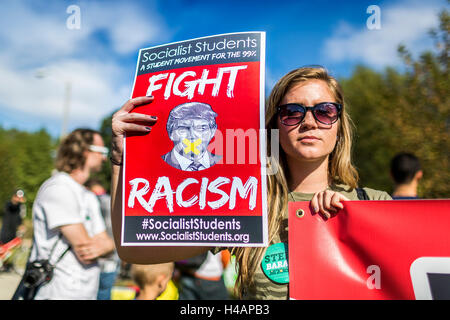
[289, 200, 450, 300]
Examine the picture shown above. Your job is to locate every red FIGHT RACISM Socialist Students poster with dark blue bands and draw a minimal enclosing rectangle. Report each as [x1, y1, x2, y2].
[121, 32, 267, 246]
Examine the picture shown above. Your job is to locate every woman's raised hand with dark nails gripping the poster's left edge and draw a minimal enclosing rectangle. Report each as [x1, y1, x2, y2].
[111, 96, 157, 163]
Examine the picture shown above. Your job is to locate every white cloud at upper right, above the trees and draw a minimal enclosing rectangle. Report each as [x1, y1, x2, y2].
[323, 1, 442, 67]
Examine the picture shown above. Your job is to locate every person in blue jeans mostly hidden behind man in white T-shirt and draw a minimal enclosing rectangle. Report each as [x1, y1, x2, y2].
[85, 178, 120, 300]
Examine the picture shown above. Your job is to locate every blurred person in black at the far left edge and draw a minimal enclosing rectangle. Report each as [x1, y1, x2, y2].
[0, 189, 27, 243]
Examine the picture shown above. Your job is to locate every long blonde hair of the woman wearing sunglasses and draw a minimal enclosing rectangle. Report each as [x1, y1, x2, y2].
[232, 67, 358, 297]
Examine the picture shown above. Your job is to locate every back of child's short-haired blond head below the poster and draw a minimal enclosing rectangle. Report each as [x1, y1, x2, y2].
[131, 262, 174, 300]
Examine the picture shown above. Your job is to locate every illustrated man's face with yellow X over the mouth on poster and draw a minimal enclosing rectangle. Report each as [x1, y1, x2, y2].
[170, 118, 216, 160]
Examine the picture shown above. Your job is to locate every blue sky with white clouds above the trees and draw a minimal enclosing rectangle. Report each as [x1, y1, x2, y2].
[0, 0, 446, 137]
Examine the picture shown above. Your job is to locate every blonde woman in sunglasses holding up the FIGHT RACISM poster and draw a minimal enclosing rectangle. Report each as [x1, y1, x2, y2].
[111, 67, 391, 299]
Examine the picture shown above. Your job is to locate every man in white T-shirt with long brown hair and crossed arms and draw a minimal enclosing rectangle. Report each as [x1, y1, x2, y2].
[19, 129, 114, 300]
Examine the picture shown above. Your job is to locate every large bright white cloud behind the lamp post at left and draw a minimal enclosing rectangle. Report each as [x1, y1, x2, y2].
[0, 60, 131, 127]
